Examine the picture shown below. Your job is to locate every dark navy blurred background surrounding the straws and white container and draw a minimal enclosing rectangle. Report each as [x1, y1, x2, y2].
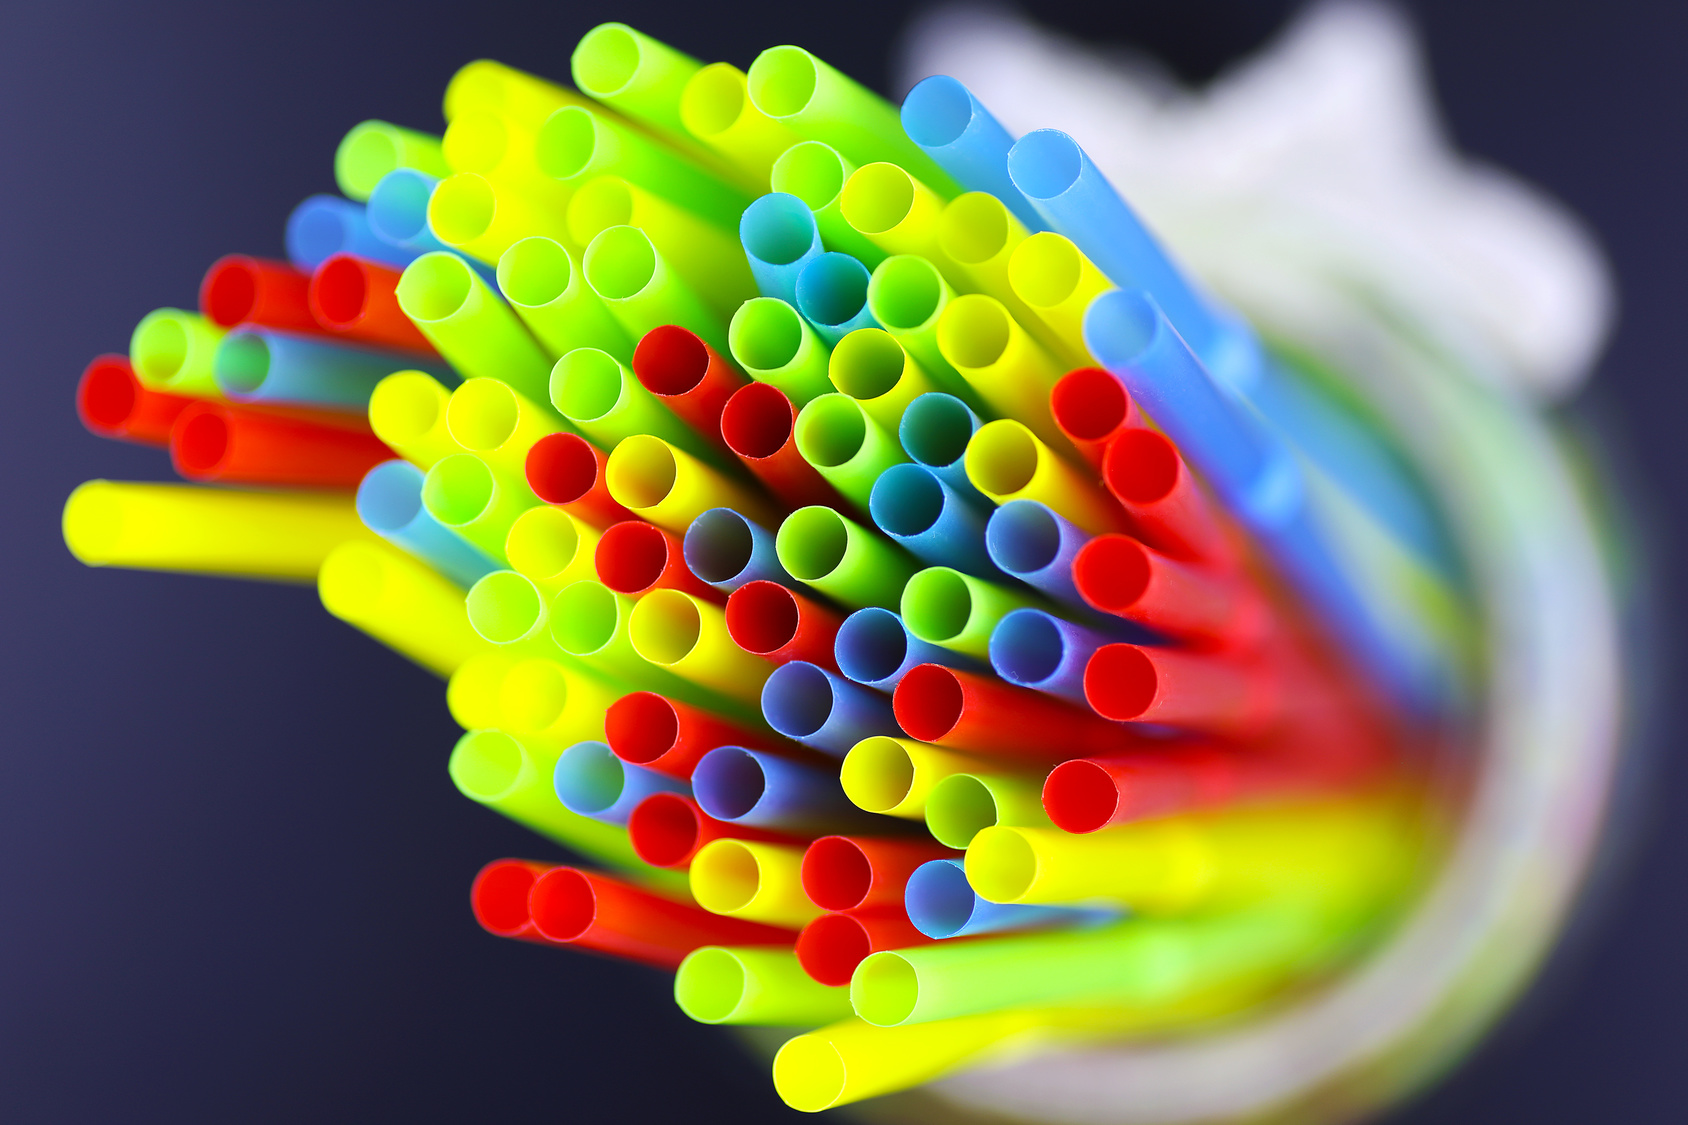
[0, 0, 1688, 1125]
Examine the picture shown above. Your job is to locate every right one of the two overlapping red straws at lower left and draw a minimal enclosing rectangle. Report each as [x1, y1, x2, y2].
[528, 867, 793, 970]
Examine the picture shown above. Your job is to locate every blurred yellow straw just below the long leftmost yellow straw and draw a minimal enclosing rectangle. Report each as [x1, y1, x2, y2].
[317, 539, 486, 677]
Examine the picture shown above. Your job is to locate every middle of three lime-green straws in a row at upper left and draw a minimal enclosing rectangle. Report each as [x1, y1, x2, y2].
[498, 236, 633, 361]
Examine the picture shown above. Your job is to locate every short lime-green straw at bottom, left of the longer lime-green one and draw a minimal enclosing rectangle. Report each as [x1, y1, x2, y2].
[674, 946, 851, 1027]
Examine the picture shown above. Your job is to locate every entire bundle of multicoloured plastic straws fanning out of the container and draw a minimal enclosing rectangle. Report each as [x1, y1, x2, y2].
[64, 24, 1460, 1110]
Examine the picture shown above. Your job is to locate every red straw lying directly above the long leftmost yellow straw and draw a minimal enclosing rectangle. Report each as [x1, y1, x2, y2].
[170, 402, 393, 488]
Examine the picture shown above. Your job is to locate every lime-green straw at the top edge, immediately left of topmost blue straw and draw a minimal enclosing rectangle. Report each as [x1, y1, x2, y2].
[746, 46, 955, 196]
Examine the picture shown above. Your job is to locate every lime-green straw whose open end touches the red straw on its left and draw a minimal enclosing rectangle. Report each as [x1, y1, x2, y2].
[398, 250, 550, 402]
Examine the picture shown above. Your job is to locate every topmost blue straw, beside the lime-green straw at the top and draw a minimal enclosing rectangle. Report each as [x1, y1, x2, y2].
[903, 74, 1043, 230]
